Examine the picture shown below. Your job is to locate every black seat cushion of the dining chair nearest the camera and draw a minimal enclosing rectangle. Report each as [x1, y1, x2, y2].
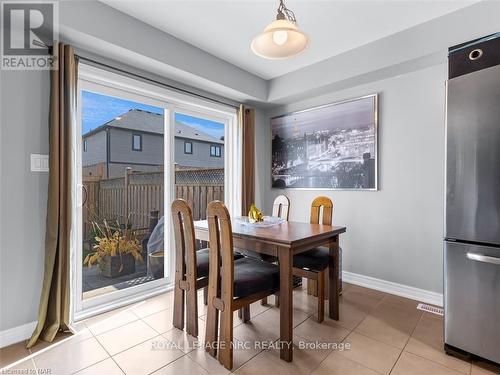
[234, 258, 280, 298]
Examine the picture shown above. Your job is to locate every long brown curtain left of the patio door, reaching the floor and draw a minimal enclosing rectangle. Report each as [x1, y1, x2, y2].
[27, 44, 78, 348]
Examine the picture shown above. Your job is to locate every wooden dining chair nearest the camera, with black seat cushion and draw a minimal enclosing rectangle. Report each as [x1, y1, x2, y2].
[205, 201, 279, 370]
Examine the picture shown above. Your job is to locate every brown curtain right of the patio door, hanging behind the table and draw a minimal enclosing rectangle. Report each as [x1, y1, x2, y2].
[238, 105, 255, 215]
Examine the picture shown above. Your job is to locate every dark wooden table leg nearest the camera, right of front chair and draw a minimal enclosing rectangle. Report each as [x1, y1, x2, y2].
[278, 247, 293, 362]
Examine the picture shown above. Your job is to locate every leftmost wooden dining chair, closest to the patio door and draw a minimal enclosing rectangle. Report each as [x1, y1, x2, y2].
[171, 199, 243, 337]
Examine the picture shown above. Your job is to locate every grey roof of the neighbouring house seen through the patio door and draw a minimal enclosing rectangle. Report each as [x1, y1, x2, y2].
[83, 109, 224, 144]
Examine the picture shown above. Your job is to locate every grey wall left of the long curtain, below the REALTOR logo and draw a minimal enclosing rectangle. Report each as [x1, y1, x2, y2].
[0, 71, 49, 331]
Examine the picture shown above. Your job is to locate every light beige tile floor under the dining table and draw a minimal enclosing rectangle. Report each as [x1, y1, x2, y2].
[0, 284, 500, 375]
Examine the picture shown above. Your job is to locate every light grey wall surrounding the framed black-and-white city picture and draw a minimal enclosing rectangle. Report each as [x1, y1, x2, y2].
[256, 64, 447, 292]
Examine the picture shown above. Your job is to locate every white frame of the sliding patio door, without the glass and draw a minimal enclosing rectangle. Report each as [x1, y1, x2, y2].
[70, 63, 242, 322]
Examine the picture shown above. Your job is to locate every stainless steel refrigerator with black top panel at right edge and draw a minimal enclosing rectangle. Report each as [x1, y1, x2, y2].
[444, 33, 500, 363]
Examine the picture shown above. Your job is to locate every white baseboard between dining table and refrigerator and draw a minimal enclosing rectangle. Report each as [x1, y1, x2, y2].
[342, 271, 443, 307]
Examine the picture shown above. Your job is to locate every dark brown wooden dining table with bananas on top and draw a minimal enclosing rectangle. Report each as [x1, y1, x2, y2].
[194, 220, 346, 362]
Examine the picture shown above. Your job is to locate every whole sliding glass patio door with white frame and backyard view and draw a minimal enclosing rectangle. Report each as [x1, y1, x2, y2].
[72, 65, 239, 321]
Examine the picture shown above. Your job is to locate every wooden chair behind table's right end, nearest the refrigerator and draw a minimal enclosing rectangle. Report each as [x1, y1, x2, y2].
[293, 197, 333, 323]
